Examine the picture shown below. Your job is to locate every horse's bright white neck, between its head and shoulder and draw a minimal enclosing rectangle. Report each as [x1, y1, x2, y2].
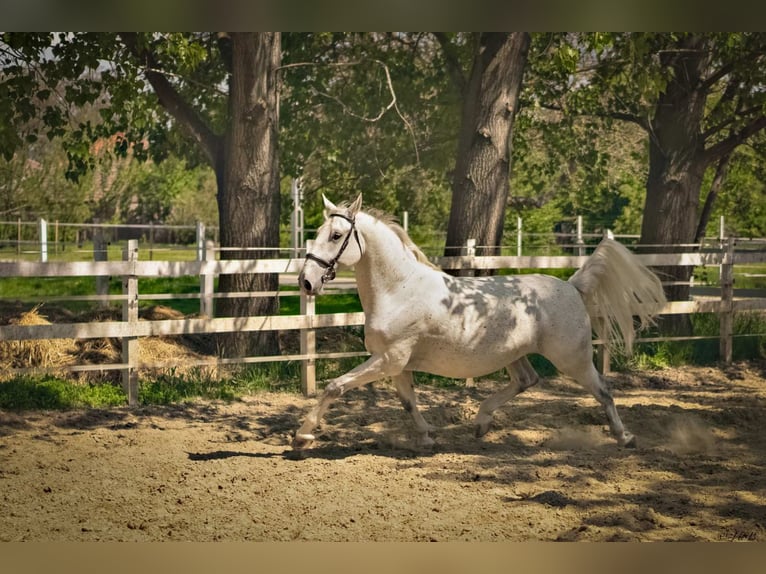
[356, 214, 423, 311]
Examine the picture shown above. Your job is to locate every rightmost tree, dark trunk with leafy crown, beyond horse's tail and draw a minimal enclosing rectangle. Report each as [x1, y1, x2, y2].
[541, 33, 766, 322]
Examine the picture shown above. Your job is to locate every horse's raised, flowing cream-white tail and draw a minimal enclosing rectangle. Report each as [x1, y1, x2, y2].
[569, 239, 666, 355]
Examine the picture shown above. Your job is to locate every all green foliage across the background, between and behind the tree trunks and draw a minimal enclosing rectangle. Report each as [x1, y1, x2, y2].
[0, 32, 766, 264]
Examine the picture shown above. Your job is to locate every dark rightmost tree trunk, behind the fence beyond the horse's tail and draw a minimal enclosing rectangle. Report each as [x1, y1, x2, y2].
[640, 36, 710, 333]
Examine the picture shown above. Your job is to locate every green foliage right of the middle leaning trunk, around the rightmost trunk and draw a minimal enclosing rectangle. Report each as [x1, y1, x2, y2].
[512, 33, 766, 250]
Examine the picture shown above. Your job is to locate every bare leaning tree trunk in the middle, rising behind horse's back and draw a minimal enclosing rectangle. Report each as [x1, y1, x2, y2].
[444, 32, 530, 276]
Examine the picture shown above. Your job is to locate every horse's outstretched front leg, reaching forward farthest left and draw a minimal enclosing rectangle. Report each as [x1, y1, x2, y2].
[293, 354, 401, 450]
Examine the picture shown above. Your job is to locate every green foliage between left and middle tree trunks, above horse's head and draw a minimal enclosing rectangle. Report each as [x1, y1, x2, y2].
[280, 33, 458, 237]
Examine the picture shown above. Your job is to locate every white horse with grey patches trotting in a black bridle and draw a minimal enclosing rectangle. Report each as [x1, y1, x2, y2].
[293, 195, 665, 450]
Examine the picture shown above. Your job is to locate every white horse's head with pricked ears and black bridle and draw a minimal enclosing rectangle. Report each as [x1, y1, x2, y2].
[298, 194, 362, 295]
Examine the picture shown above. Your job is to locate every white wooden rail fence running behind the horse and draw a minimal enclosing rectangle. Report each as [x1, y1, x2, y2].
[0, 239, 766, 404]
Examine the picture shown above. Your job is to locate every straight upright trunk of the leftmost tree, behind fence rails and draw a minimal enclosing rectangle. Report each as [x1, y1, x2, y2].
[216, 33, 281, 356]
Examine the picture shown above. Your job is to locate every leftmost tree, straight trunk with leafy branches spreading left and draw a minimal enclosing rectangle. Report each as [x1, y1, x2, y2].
[0, 33, 281, 355]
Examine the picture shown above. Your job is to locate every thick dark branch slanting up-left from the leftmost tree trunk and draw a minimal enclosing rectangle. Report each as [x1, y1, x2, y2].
[118, 32, 221, 169]
